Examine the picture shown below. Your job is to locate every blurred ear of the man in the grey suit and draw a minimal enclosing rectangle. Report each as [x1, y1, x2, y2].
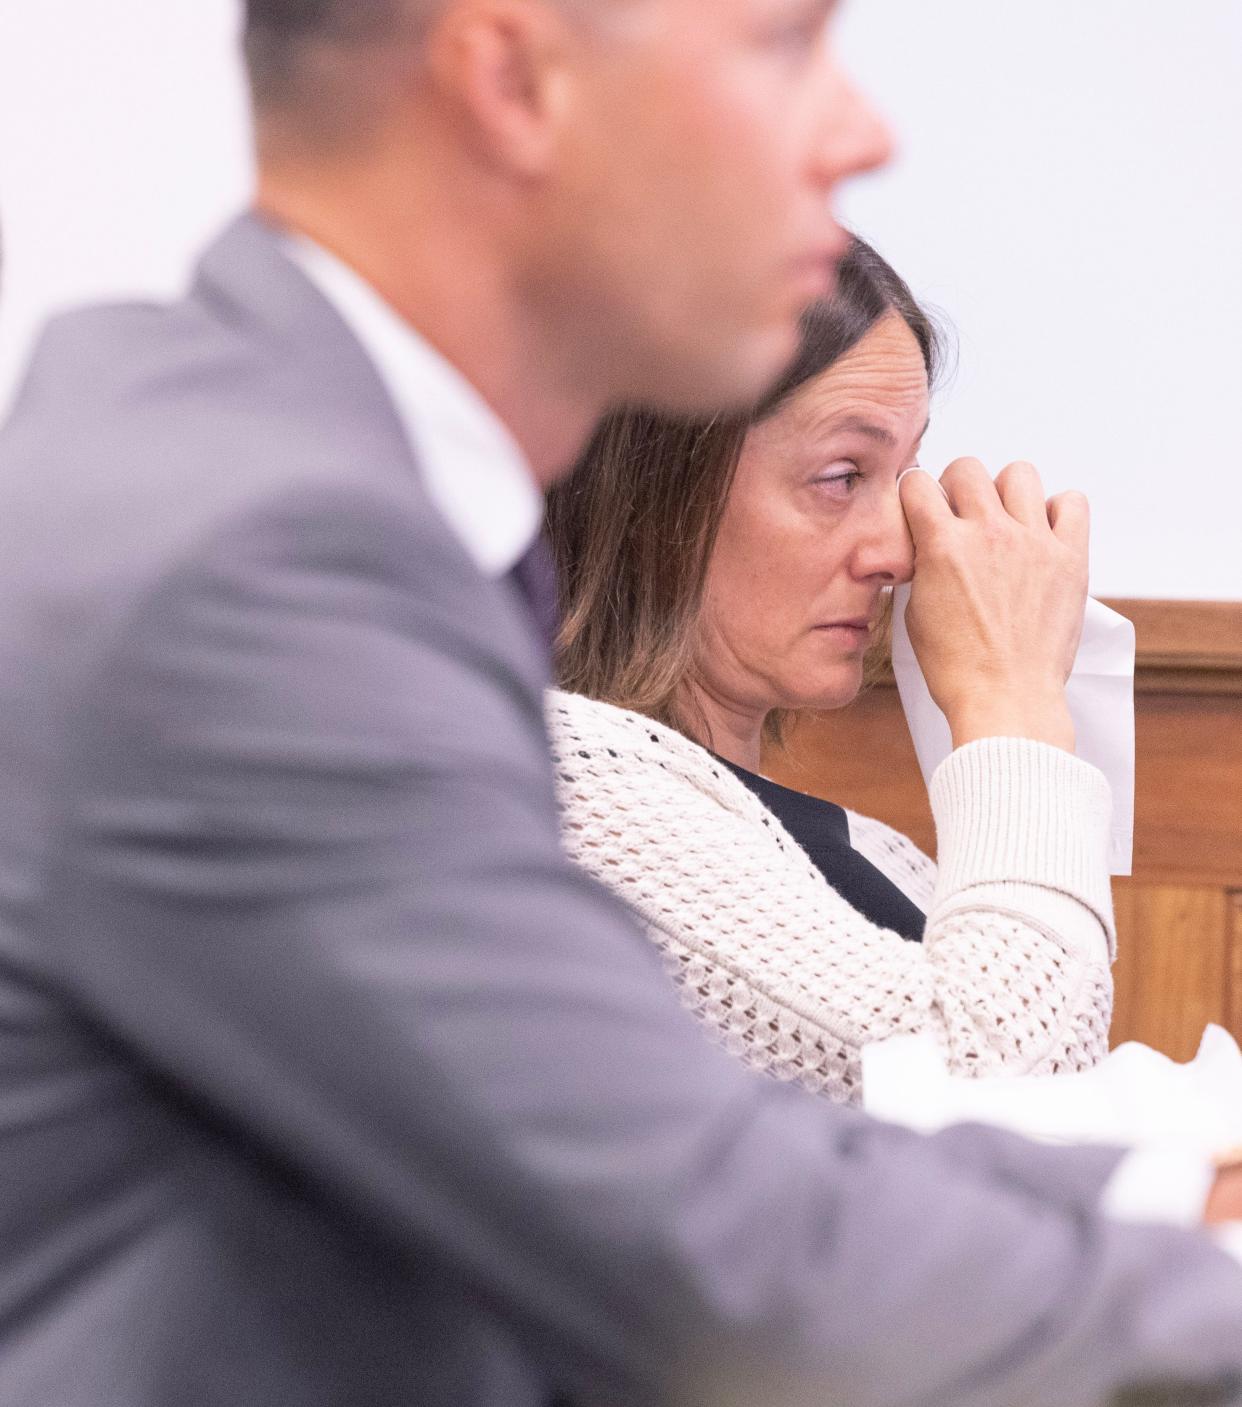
[426, 0, 572, 179]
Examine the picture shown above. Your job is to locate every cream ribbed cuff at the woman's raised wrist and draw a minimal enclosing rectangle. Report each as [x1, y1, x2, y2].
[928, 737, 1115, 946]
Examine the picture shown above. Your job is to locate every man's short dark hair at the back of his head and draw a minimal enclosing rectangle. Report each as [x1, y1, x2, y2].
[245, 0, 416, 108]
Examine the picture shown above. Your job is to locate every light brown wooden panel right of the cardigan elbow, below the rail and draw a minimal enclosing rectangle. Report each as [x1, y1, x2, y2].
[1113, 879, 1242, 1059]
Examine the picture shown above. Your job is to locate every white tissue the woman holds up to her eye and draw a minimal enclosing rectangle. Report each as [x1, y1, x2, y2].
[893, 585, 1135, 875]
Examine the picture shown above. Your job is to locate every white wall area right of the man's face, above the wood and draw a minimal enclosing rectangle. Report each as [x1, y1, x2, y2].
[844, 0, 1242, 599]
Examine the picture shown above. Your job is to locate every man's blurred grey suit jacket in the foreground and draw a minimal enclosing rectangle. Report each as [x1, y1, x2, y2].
[0, 211, 1242, 1407]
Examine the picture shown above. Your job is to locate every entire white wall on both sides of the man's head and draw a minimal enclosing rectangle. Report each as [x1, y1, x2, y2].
[0, 0, 1242, 599]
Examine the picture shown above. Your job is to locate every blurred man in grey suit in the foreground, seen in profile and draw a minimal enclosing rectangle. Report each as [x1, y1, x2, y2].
[0, 0, 1242, 1407]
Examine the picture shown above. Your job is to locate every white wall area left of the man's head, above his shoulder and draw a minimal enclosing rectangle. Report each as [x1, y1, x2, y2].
[0, 0, 250, 404]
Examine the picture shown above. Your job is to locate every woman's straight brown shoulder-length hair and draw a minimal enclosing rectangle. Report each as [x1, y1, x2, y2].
[547, 239, 940, 741]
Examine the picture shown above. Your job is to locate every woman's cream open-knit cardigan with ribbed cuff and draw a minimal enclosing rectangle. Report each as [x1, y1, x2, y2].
[547, 691, 1114, 1102]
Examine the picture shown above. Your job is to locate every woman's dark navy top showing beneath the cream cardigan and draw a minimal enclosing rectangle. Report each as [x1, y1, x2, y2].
[720, 757, 927, 943]
